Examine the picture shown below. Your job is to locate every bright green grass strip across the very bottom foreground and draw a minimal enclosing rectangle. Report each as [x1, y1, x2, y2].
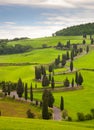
[0, 117, 94, 130]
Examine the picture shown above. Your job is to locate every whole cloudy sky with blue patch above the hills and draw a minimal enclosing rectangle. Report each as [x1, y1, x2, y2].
[0, 0, 94, 39]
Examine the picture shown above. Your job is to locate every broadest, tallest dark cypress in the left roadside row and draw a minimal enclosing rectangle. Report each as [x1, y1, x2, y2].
[17, 78, 24, 98]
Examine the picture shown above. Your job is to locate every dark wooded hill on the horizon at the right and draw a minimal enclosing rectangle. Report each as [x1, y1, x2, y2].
[55, 23, 94, 36]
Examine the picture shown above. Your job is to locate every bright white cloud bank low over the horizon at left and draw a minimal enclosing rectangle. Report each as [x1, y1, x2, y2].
[0, 26, 61, 39]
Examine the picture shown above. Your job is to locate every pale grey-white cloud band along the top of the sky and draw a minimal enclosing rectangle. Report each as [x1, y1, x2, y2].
[0, 0, 94, 8]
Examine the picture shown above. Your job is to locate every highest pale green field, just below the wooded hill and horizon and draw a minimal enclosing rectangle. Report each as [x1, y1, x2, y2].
[8, 36, 90, 48]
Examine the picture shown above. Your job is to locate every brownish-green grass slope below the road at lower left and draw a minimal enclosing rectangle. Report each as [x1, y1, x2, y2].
[0, 98, 41, 118]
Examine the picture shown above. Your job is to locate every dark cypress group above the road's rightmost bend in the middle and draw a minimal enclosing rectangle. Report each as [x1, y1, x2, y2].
[64, 71, 83, 87]
